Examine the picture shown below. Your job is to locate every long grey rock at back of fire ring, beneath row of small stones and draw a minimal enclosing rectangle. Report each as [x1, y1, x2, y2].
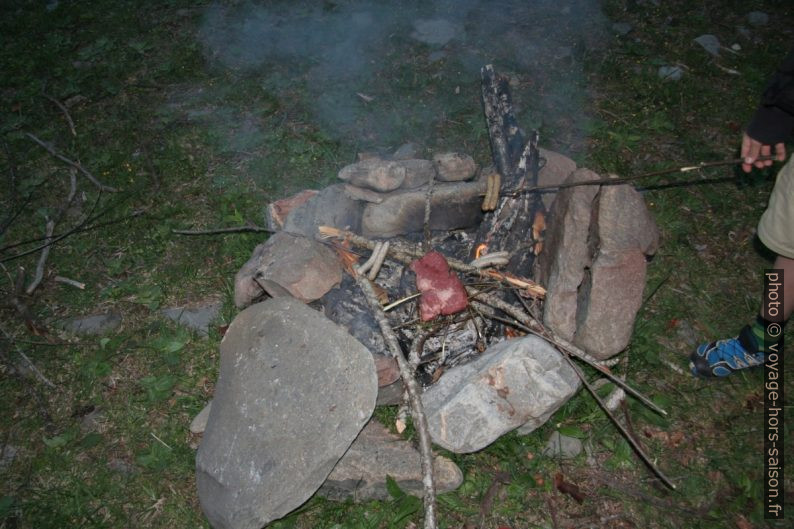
[361, 181, 485, 237]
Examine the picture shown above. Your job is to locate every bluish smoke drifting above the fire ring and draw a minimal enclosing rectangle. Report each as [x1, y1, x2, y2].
[199, 0, 606, 154]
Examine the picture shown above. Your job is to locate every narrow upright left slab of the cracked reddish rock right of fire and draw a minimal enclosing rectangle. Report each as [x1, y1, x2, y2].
[537, 169, 600, 340]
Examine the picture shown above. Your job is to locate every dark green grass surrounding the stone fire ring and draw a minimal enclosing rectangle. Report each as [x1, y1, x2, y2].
[0, 0, 794, 529]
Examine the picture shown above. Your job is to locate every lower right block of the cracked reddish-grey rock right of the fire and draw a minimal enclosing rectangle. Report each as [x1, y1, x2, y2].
[573, 249, 647, 360]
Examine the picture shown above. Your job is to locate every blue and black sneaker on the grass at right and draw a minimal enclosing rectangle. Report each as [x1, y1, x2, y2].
[689, 326, 766, 378]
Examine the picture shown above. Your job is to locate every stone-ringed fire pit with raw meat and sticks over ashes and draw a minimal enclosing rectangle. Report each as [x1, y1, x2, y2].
[192, 67, 658, 527]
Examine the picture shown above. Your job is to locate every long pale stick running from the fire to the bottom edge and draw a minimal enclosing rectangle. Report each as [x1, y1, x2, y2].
[354, 267, 437, 529]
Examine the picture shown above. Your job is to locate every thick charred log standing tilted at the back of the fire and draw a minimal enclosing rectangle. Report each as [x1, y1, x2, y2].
[475, 65, 546, 276]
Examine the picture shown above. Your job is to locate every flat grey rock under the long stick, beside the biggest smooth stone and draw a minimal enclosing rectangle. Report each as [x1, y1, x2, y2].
[317, 420, 463, 501]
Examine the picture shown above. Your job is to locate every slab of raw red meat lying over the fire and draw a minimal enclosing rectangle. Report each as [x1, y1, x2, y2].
[411, 252, 468, 321]
